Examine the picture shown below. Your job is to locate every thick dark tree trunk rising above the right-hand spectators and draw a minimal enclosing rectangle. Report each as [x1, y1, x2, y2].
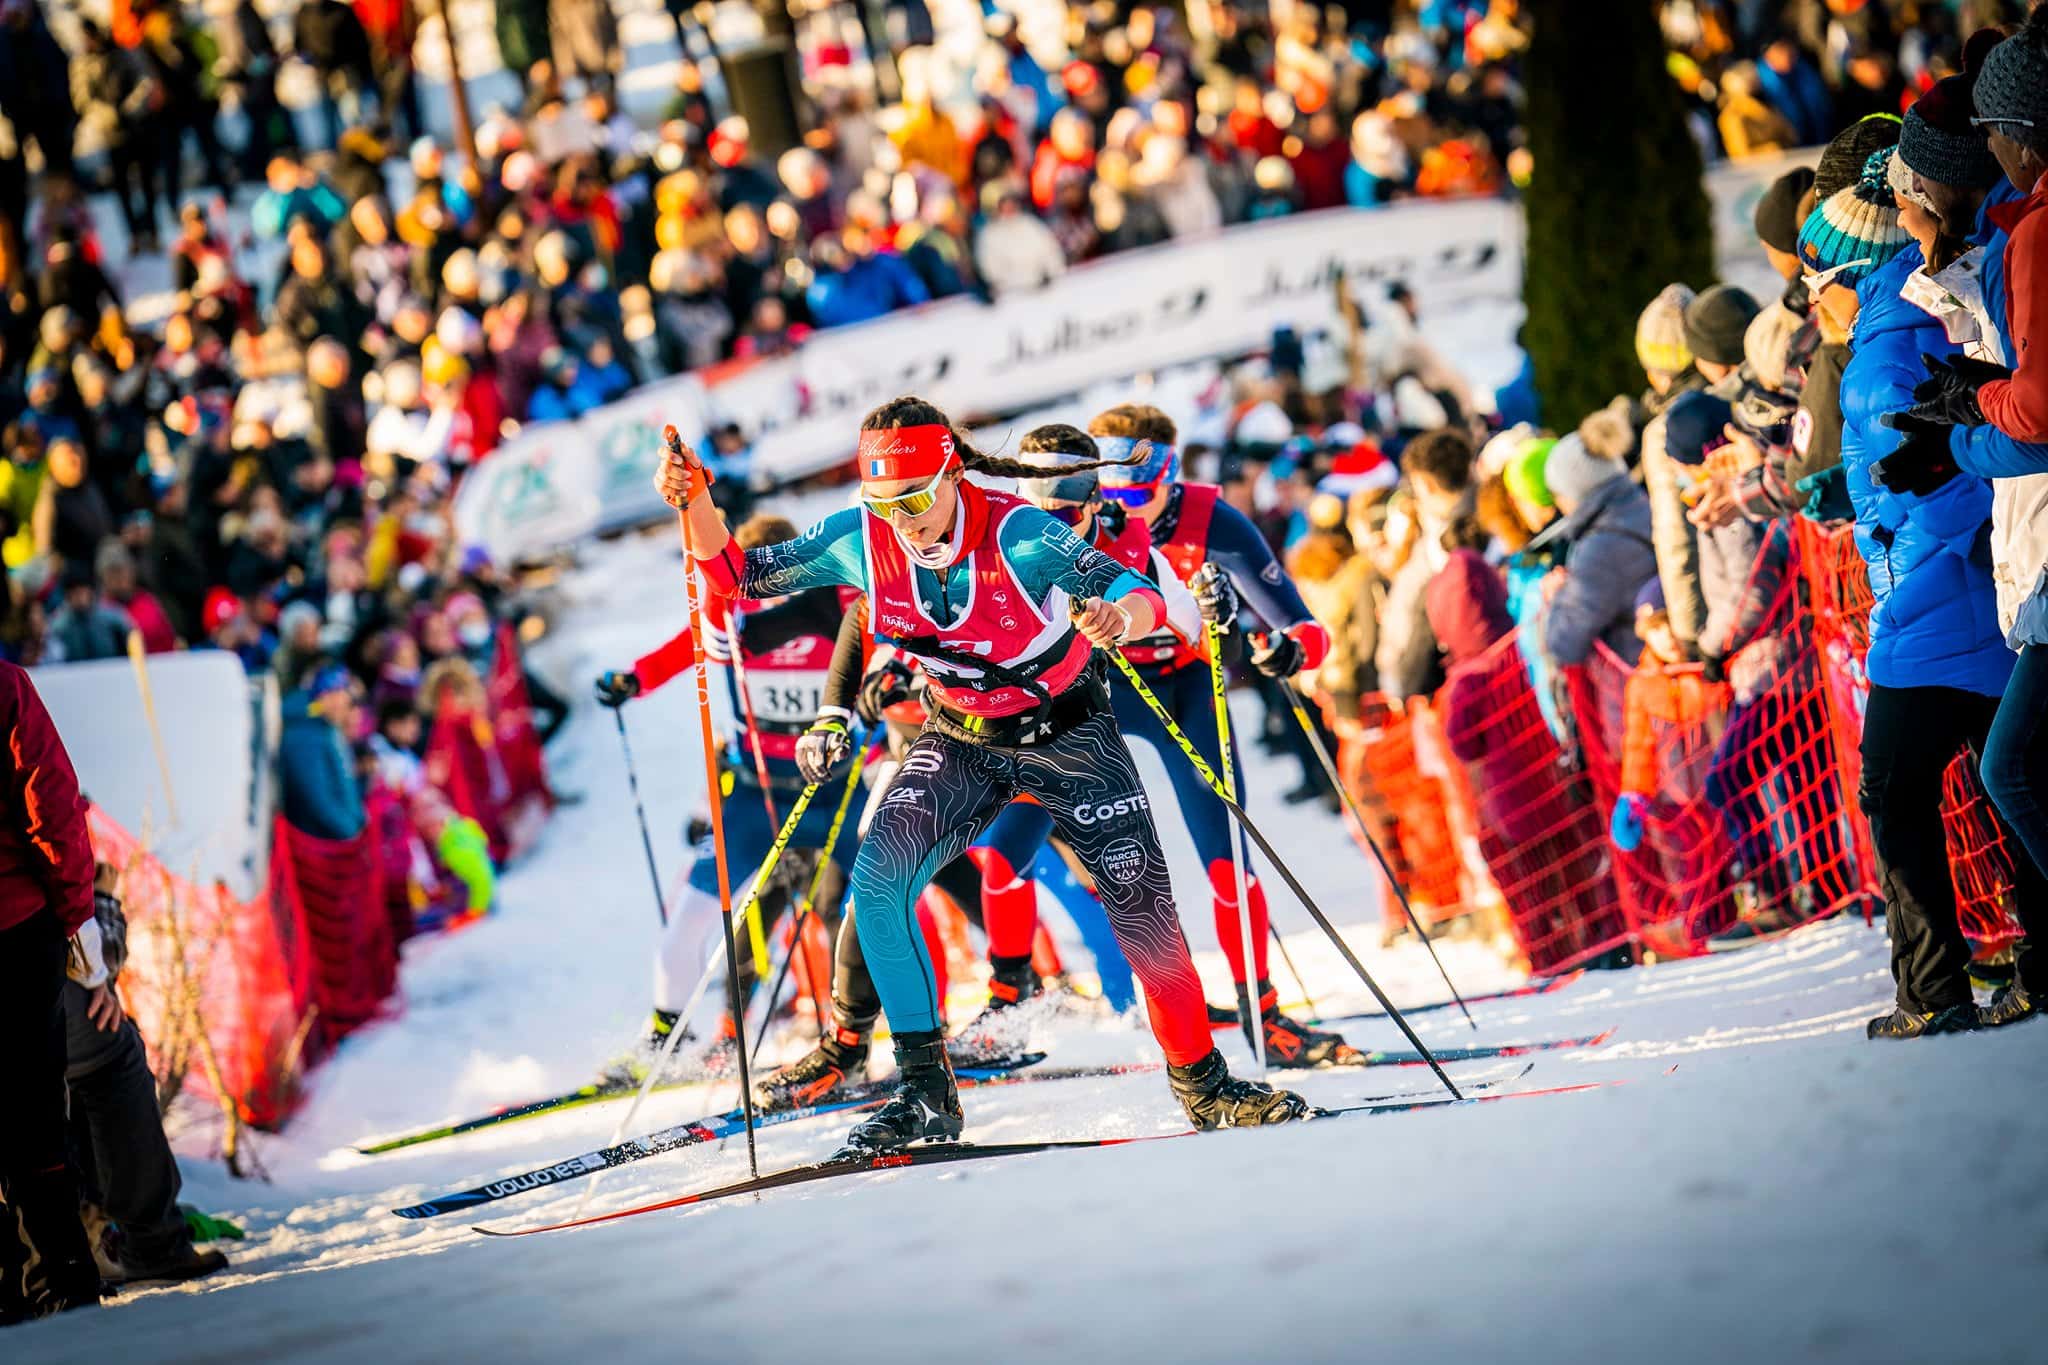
[1522, 0, 1714, 430]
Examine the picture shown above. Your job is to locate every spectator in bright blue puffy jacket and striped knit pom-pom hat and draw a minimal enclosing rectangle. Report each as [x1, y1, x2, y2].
[1798, 149, 2040, 1038]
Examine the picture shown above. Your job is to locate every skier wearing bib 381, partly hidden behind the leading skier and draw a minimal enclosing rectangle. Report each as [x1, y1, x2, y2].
[598, 516, 860, 1085]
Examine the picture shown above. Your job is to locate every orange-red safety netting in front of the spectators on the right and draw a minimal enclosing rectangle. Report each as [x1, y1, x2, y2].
[1337, 520, 2019, 970]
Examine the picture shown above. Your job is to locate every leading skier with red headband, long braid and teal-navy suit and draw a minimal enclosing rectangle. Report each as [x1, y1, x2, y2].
[655, 397, 1309, 1150]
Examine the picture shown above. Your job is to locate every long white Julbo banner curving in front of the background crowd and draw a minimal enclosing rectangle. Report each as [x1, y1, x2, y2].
[455, 199, 1522, 563]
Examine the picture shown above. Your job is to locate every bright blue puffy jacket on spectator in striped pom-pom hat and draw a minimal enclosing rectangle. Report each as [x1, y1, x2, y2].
[1841, 248, 2013, 696]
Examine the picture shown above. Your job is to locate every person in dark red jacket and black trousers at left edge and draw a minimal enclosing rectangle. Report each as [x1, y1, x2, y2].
[0, 663, 106, 1324]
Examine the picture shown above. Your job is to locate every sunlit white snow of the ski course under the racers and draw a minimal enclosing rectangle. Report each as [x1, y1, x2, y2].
[16, 482, 2048, 1365]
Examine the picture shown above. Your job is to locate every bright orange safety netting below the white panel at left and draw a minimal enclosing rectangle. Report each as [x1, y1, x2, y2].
[86, 806, 313, 1128]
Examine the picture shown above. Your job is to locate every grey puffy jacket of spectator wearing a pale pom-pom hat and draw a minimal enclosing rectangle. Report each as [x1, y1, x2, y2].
[1542, 475, 1657, 667]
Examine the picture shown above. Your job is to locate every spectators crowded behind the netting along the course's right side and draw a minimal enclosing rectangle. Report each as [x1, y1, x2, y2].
[1214, 4, 2048, 1038]
